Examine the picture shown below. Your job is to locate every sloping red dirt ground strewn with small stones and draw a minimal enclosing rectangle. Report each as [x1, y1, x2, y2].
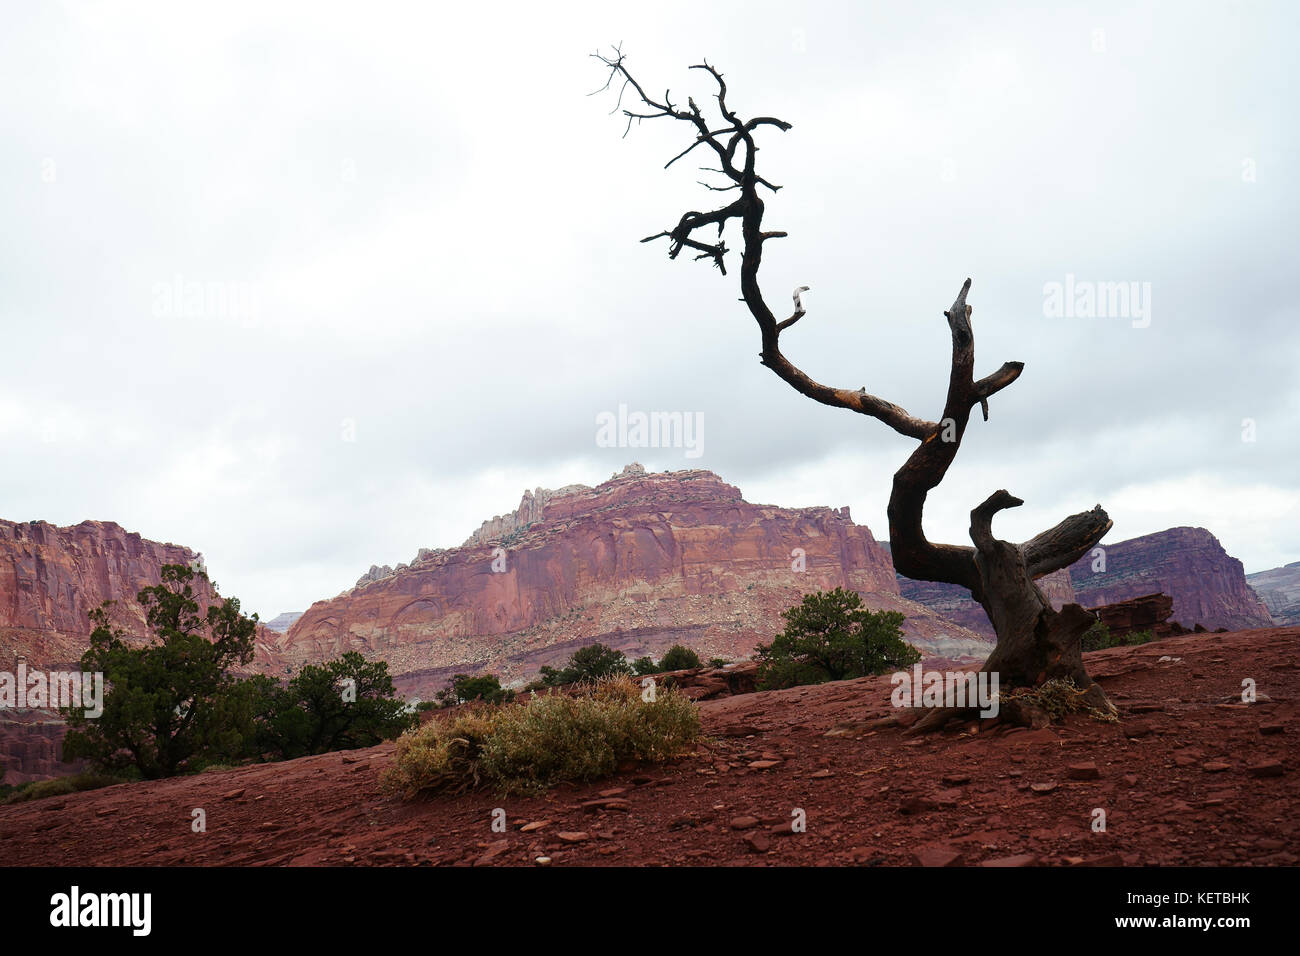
[0, 627, 1300, 866]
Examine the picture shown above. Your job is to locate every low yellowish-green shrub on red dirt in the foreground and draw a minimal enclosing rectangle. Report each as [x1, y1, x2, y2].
[382, 675, 699, 799]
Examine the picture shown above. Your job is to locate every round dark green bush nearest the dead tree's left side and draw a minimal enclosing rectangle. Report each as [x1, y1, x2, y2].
[755, 588, 920, 691]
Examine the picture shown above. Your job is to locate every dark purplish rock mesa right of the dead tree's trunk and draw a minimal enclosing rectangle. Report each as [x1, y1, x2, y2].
[1070, 528, 1274, 631]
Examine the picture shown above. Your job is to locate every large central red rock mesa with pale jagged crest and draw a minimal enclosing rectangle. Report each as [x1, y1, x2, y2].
[267, 466, 988, 697]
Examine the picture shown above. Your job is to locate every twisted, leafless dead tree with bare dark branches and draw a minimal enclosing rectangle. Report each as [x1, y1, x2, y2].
[594, 48, 1115, 731]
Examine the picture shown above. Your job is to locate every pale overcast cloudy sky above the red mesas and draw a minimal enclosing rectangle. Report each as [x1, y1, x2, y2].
[0, 1, 1300, 618]
